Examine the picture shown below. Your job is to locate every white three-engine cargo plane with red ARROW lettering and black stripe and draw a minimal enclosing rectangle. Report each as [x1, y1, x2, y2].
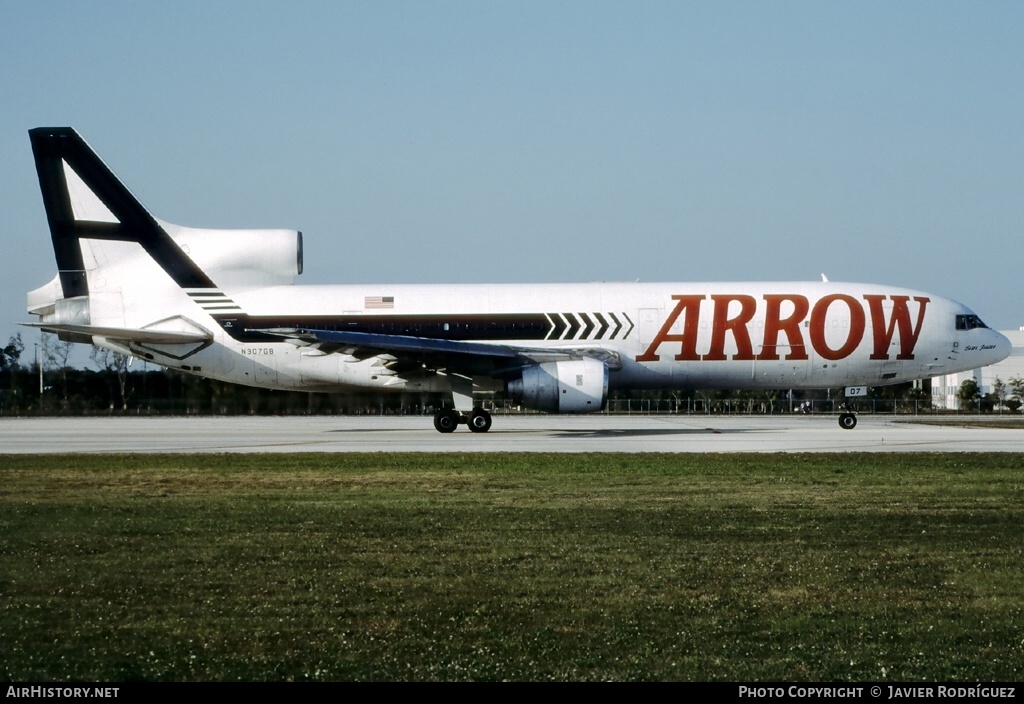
[25, 127, 1011, 433]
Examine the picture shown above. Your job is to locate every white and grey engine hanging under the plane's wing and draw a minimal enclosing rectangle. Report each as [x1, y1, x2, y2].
[508, 357, 608, 413]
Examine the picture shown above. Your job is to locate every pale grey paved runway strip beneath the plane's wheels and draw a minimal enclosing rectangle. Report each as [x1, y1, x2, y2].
[0, 415, 1024, 453]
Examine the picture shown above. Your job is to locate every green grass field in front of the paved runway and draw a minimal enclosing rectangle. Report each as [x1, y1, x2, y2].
[0, 453, 1024, 681]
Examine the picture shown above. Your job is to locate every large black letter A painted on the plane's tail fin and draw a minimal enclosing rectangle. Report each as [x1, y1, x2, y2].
[29, 127, 216, 298]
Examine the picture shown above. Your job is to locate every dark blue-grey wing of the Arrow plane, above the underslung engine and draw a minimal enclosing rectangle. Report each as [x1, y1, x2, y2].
[259, 328, 622, 376]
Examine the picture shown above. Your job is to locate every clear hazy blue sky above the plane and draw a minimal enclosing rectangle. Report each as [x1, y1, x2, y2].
[0, 0, 1024, 362]
